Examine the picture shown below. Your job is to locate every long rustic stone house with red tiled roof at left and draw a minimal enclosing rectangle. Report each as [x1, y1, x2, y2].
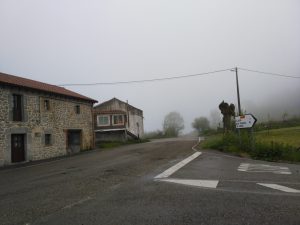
[0, 73, 97, 165]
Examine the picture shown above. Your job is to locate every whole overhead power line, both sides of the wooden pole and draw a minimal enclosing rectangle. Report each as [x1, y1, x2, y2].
[58, 67, 300, 86]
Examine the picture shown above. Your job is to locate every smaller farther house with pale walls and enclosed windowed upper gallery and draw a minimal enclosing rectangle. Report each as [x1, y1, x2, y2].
[94, 98, 144, 142]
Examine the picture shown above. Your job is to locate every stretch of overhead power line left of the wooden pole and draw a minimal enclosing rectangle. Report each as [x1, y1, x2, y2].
[58, 68, 232, 86]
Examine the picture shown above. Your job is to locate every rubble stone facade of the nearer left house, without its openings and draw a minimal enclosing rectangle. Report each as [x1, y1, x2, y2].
[0, 85, 94, 165]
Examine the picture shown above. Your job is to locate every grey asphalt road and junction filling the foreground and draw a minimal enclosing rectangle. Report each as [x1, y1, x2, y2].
[0, 139, 300, 225]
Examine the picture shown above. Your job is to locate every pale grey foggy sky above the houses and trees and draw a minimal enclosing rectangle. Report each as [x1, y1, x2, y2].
[0, 0, 300, 131]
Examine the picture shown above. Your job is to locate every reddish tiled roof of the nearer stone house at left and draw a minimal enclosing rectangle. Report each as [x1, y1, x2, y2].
[0, 72, 98, 103]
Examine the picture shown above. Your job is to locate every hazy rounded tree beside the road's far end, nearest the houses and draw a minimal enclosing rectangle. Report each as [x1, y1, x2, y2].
[163, 112, 184, 137]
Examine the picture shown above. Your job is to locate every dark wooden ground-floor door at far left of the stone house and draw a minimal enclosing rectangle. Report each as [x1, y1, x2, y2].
[11, 134, 25, 163]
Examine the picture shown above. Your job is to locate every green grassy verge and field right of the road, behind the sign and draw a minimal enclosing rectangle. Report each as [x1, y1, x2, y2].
[201, 118, 300, 162]
